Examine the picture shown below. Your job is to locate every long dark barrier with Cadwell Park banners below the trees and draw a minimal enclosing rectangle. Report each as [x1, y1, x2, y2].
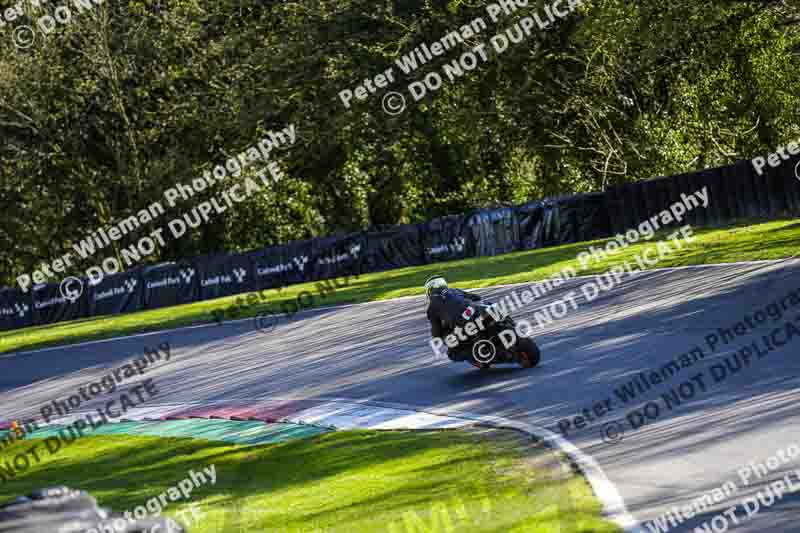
[0, 154, 800, 330]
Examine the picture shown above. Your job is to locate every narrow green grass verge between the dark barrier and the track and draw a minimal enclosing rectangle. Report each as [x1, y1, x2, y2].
[0, 216, 800, 353]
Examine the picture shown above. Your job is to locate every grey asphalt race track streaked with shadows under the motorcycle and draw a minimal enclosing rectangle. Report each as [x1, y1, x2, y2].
[0, 259, 800, 532]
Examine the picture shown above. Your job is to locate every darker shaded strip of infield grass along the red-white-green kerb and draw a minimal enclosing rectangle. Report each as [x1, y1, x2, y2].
[0, 431, 472, 500]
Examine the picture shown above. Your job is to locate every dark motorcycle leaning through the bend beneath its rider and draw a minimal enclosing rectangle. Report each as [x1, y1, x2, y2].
[446, 303, 541, 370]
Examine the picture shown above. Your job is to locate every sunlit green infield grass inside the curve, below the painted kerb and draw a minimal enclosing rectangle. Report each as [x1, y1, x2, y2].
[0, 431, 620, 533]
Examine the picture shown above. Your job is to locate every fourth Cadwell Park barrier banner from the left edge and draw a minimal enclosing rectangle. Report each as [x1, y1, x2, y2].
[141, 261, 200, 309]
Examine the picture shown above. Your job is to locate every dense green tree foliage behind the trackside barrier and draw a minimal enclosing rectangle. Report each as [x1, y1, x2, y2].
[0, 0, 800, 284]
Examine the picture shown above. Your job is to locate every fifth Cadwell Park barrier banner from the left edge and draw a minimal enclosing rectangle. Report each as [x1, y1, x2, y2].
[194, 254, 256, 300]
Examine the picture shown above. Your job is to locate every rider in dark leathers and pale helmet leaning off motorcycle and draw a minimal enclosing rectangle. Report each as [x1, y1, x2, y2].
[425, 275, 481, 365]
